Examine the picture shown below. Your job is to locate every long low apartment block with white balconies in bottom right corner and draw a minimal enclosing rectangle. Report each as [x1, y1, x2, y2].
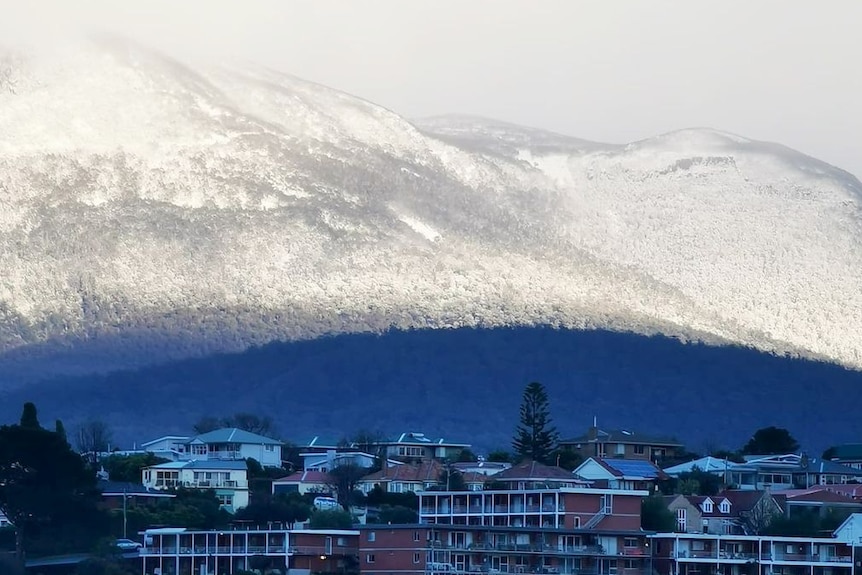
[652, 530, 862, 575]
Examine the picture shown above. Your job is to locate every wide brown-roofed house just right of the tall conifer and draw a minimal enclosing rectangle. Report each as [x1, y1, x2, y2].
[559, 424, 683, 461]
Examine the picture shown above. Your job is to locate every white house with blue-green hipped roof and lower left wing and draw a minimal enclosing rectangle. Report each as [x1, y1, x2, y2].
[141, 427, 282, 467]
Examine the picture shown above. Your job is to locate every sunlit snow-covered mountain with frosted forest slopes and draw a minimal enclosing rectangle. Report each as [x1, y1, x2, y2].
[0, 35, 862, 378]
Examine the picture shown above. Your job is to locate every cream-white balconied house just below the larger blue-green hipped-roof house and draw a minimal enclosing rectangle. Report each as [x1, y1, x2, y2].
[141, 459, 248, 512]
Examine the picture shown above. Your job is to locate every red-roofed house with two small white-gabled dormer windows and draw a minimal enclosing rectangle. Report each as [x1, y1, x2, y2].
[664, 490, 784, 535]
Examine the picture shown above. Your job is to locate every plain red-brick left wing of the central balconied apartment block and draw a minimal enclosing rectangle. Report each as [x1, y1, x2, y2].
[359, 525, 428, 575]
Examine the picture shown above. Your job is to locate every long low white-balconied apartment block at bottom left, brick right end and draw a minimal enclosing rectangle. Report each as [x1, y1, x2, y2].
[140, 528, 359, 575]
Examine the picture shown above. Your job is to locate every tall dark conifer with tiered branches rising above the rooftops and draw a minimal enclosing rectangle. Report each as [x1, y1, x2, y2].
[512, 381, 559, 464]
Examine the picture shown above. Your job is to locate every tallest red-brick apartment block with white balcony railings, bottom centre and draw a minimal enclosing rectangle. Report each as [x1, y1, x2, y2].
[416, 487, 649, 575]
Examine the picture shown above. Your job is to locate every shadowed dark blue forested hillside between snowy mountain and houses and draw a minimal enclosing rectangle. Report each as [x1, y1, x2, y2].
[0, 328, 862, 453]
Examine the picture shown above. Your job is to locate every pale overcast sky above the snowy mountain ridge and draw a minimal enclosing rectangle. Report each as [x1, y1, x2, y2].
[0, 0, 862, 177]
